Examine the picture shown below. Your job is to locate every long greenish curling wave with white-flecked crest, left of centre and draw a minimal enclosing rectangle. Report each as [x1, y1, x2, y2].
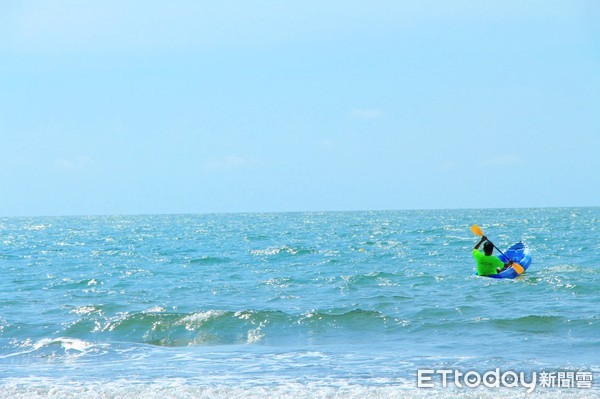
[56, 307, 407, 346]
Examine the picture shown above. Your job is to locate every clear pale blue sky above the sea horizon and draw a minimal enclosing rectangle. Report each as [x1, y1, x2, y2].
[0, 0, 600, 217]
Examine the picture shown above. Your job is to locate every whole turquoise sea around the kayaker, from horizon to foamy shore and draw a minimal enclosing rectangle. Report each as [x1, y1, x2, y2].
[0, 208, 600, 398]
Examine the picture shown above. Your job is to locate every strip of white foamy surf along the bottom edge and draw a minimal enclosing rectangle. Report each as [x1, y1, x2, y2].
[0, 377, 600, 399]
